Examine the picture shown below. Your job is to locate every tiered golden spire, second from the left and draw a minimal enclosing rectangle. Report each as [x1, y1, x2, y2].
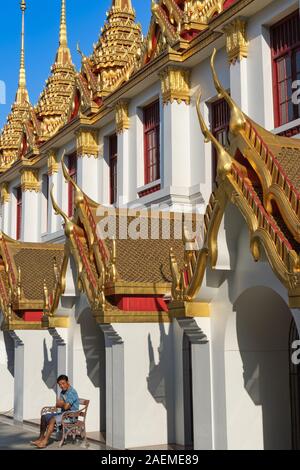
[35, 0, 76, 141]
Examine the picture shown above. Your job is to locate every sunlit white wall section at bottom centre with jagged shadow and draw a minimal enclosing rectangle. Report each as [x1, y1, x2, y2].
[113, 324, 174, 448]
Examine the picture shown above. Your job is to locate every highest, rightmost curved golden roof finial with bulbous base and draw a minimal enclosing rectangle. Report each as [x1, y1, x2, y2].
[210, 49, 246, 135]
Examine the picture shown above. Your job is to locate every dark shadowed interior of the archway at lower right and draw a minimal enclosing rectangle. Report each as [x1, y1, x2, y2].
[234, 287, 292, 449]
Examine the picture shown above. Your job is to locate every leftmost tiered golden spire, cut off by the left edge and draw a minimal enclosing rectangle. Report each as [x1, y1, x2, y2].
[0, 0, 31, 169]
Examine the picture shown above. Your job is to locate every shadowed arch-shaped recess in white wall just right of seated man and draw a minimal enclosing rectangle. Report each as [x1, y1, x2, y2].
[78, 308, 106, 432]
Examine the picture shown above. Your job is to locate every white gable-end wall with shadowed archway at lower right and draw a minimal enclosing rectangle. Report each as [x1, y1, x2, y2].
[200, 209, 292, 449]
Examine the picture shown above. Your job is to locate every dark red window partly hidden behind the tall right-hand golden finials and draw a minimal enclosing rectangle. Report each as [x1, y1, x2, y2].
[211, 99, 230, 180]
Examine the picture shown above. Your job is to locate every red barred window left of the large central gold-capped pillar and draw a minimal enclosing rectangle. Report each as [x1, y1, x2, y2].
[144, 101, 160, 184]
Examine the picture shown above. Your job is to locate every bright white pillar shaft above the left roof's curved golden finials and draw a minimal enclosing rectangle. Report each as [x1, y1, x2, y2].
[77, 155, 99, 202]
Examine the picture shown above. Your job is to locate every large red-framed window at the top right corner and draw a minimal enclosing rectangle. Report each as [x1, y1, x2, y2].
[271, 10, 300, 127]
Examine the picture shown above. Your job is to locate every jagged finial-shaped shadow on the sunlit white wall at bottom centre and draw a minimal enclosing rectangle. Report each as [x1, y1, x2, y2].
[147, 322, 174, 443]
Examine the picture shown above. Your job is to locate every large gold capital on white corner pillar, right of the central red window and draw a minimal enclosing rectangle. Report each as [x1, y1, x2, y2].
[160, 67, 191, 104]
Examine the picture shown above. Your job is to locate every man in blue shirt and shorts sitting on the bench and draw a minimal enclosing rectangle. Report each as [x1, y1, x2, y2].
[32, 375, 79, 449]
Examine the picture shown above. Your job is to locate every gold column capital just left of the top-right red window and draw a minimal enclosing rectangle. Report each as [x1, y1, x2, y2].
[224, 18, 249, 64]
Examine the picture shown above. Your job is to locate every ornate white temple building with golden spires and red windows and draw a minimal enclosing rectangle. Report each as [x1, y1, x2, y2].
[0, 0, 300, 450]
